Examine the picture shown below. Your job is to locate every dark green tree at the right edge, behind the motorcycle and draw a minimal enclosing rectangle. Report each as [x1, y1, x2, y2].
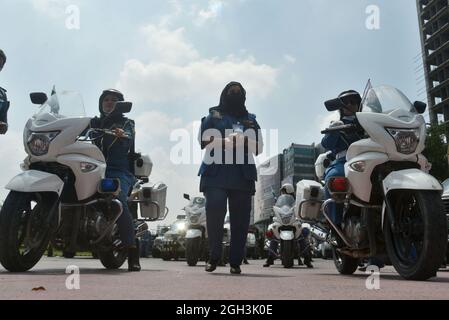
[423, 124, 449, 181]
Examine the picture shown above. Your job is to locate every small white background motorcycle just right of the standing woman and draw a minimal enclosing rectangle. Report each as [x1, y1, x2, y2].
[266, 194, 304, 268]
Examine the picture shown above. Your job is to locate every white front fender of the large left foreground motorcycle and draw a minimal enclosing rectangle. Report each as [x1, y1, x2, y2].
[5, 170, 64, 196]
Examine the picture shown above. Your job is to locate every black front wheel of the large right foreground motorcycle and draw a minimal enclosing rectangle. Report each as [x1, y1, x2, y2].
[384, 190, 448, 281]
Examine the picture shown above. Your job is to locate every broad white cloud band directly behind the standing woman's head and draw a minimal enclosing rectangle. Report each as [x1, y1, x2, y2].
[117, 57, 278, 107]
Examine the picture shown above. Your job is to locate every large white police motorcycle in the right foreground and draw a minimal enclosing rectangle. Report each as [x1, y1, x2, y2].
[316, 86, 448, 280]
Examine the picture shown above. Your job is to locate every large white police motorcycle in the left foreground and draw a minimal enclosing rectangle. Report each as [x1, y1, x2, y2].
[0, 91, 166, 272]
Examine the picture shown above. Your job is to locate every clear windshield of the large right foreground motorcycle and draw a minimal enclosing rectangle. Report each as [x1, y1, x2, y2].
[362, 86, 417, 114]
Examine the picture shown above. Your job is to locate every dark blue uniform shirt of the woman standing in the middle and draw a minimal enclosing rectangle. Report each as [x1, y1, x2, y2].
[198, 108, 262, 193]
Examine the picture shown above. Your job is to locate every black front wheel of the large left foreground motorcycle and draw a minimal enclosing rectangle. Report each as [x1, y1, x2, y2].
[0, 191, 57, 272]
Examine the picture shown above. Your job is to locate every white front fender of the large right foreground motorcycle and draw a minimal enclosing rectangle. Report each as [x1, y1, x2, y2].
[382, 169, 443, 225]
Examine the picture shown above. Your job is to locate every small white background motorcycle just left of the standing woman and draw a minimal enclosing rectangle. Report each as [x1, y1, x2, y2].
[184, 194, 208, 267]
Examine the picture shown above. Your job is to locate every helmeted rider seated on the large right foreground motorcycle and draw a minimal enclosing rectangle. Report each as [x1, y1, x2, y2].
[321, 90, 383, 268]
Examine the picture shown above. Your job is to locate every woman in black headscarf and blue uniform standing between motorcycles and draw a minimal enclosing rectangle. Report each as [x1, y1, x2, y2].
[199, 82, 263, 274]
